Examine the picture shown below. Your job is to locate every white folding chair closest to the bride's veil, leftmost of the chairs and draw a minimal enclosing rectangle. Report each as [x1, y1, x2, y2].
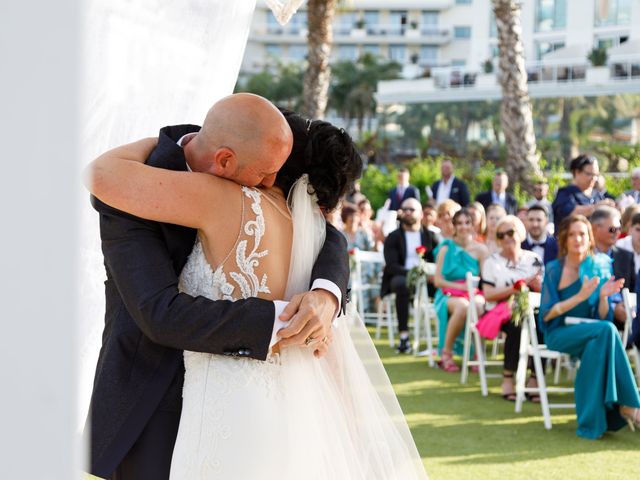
[351, 250, 396, 347]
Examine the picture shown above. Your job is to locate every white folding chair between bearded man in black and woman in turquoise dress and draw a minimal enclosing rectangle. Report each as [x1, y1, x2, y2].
[413, 263, 438, 367]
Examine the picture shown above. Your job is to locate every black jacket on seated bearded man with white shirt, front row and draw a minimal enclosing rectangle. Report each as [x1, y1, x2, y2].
[380, 227, 438, 297]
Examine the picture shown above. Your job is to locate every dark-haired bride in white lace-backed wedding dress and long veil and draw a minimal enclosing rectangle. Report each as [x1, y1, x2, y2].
[88, 106, 426, 480]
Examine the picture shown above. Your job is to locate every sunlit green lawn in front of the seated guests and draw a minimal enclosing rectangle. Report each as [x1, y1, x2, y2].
[376, 341, 640, 480]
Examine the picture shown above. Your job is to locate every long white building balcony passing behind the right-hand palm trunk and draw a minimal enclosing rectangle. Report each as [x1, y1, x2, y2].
[376, 56, 640, 105]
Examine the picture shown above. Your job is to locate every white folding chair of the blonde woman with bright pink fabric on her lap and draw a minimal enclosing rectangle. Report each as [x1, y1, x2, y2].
[460, 272, 503, 397]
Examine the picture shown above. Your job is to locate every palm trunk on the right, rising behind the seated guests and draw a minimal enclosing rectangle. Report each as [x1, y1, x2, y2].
[493, 0, 542, 190]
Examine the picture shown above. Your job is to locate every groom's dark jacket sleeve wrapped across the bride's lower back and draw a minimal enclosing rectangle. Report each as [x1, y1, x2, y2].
[92, 197, 275, 360]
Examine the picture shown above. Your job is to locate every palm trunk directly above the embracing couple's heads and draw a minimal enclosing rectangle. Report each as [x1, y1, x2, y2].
[302, 0, 336, 119]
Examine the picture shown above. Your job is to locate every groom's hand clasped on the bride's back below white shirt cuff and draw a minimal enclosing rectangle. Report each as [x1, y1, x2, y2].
[277, 290, 338, 357]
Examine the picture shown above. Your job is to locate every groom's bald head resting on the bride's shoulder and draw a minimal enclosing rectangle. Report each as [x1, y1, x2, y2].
[185, 93, 293, 187]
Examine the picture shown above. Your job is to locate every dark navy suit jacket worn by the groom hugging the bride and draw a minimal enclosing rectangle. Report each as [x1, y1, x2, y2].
[85, 125, 349, 478]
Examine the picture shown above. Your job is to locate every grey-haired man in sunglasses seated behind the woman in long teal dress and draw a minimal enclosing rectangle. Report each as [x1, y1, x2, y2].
[589, 206, 638, 328]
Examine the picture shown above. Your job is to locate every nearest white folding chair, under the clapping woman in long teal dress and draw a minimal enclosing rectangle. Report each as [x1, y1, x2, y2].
[516, 292, 576, 430]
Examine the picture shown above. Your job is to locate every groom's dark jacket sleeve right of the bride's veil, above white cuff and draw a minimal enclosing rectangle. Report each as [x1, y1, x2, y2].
[311, 222, 349, 312]
